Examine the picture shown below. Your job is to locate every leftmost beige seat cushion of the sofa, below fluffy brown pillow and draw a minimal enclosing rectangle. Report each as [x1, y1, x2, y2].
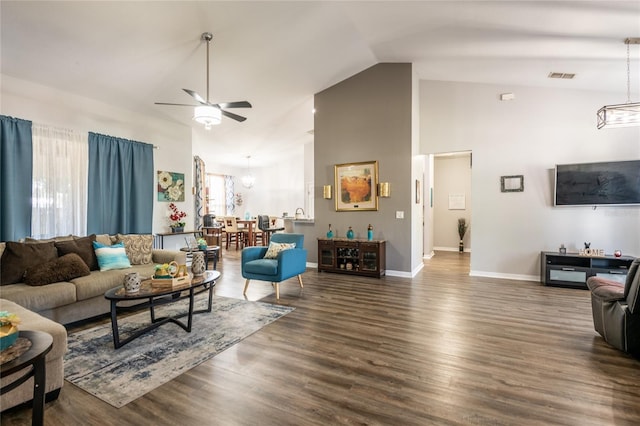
[2, 282, 77, 312]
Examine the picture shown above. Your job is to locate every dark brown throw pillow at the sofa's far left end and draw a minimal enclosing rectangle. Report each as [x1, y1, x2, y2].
[0, 241, 58, 284]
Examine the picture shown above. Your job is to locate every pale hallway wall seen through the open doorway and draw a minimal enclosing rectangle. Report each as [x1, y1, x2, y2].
[433, 153, 473, 251]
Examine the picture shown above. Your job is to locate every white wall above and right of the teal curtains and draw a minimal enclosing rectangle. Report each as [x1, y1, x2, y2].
[0, 75, 193, 233]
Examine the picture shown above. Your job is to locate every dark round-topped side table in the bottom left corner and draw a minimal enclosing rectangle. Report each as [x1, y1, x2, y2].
[0, 330, 53, 425]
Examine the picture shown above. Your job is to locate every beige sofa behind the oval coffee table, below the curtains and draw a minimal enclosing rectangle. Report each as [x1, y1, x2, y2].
[0, 234, 186, 324]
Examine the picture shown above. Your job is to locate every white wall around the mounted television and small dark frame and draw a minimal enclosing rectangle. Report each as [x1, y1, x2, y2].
[421, 81, 640, 280]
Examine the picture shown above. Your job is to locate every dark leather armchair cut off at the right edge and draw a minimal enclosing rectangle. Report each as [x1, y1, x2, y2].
[587, 258, 640, 355]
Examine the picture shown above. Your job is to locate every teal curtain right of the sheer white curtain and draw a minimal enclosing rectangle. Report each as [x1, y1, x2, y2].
[87, 132, 154, 234]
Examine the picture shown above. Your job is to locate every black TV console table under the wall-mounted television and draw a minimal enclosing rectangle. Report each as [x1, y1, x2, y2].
[540, 251, 635, 289]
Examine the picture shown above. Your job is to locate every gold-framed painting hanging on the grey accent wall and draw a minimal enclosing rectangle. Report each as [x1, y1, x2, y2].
[335, 161, 378, 212]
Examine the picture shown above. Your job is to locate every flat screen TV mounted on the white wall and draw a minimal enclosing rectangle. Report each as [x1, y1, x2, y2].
[554, 160, 640, 206]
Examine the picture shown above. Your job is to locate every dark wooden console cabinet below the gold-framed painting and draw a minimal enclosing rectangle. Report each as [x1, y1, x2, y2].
[318, 238, 386, 278]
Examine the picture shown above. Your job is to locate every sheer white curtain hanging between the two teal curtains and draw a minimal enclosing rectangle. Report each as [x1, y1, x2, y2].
[31, 123, 89, 238]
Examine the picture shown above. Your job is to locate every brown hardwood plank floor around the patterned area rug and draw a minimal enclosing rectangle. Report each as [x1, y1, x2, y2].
[1, 250, 640, 426]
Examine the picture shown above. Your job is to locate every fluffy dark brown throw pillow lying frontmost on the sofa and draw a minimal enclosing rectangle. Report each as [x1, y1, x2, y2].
[24, 253, 91, 286]
